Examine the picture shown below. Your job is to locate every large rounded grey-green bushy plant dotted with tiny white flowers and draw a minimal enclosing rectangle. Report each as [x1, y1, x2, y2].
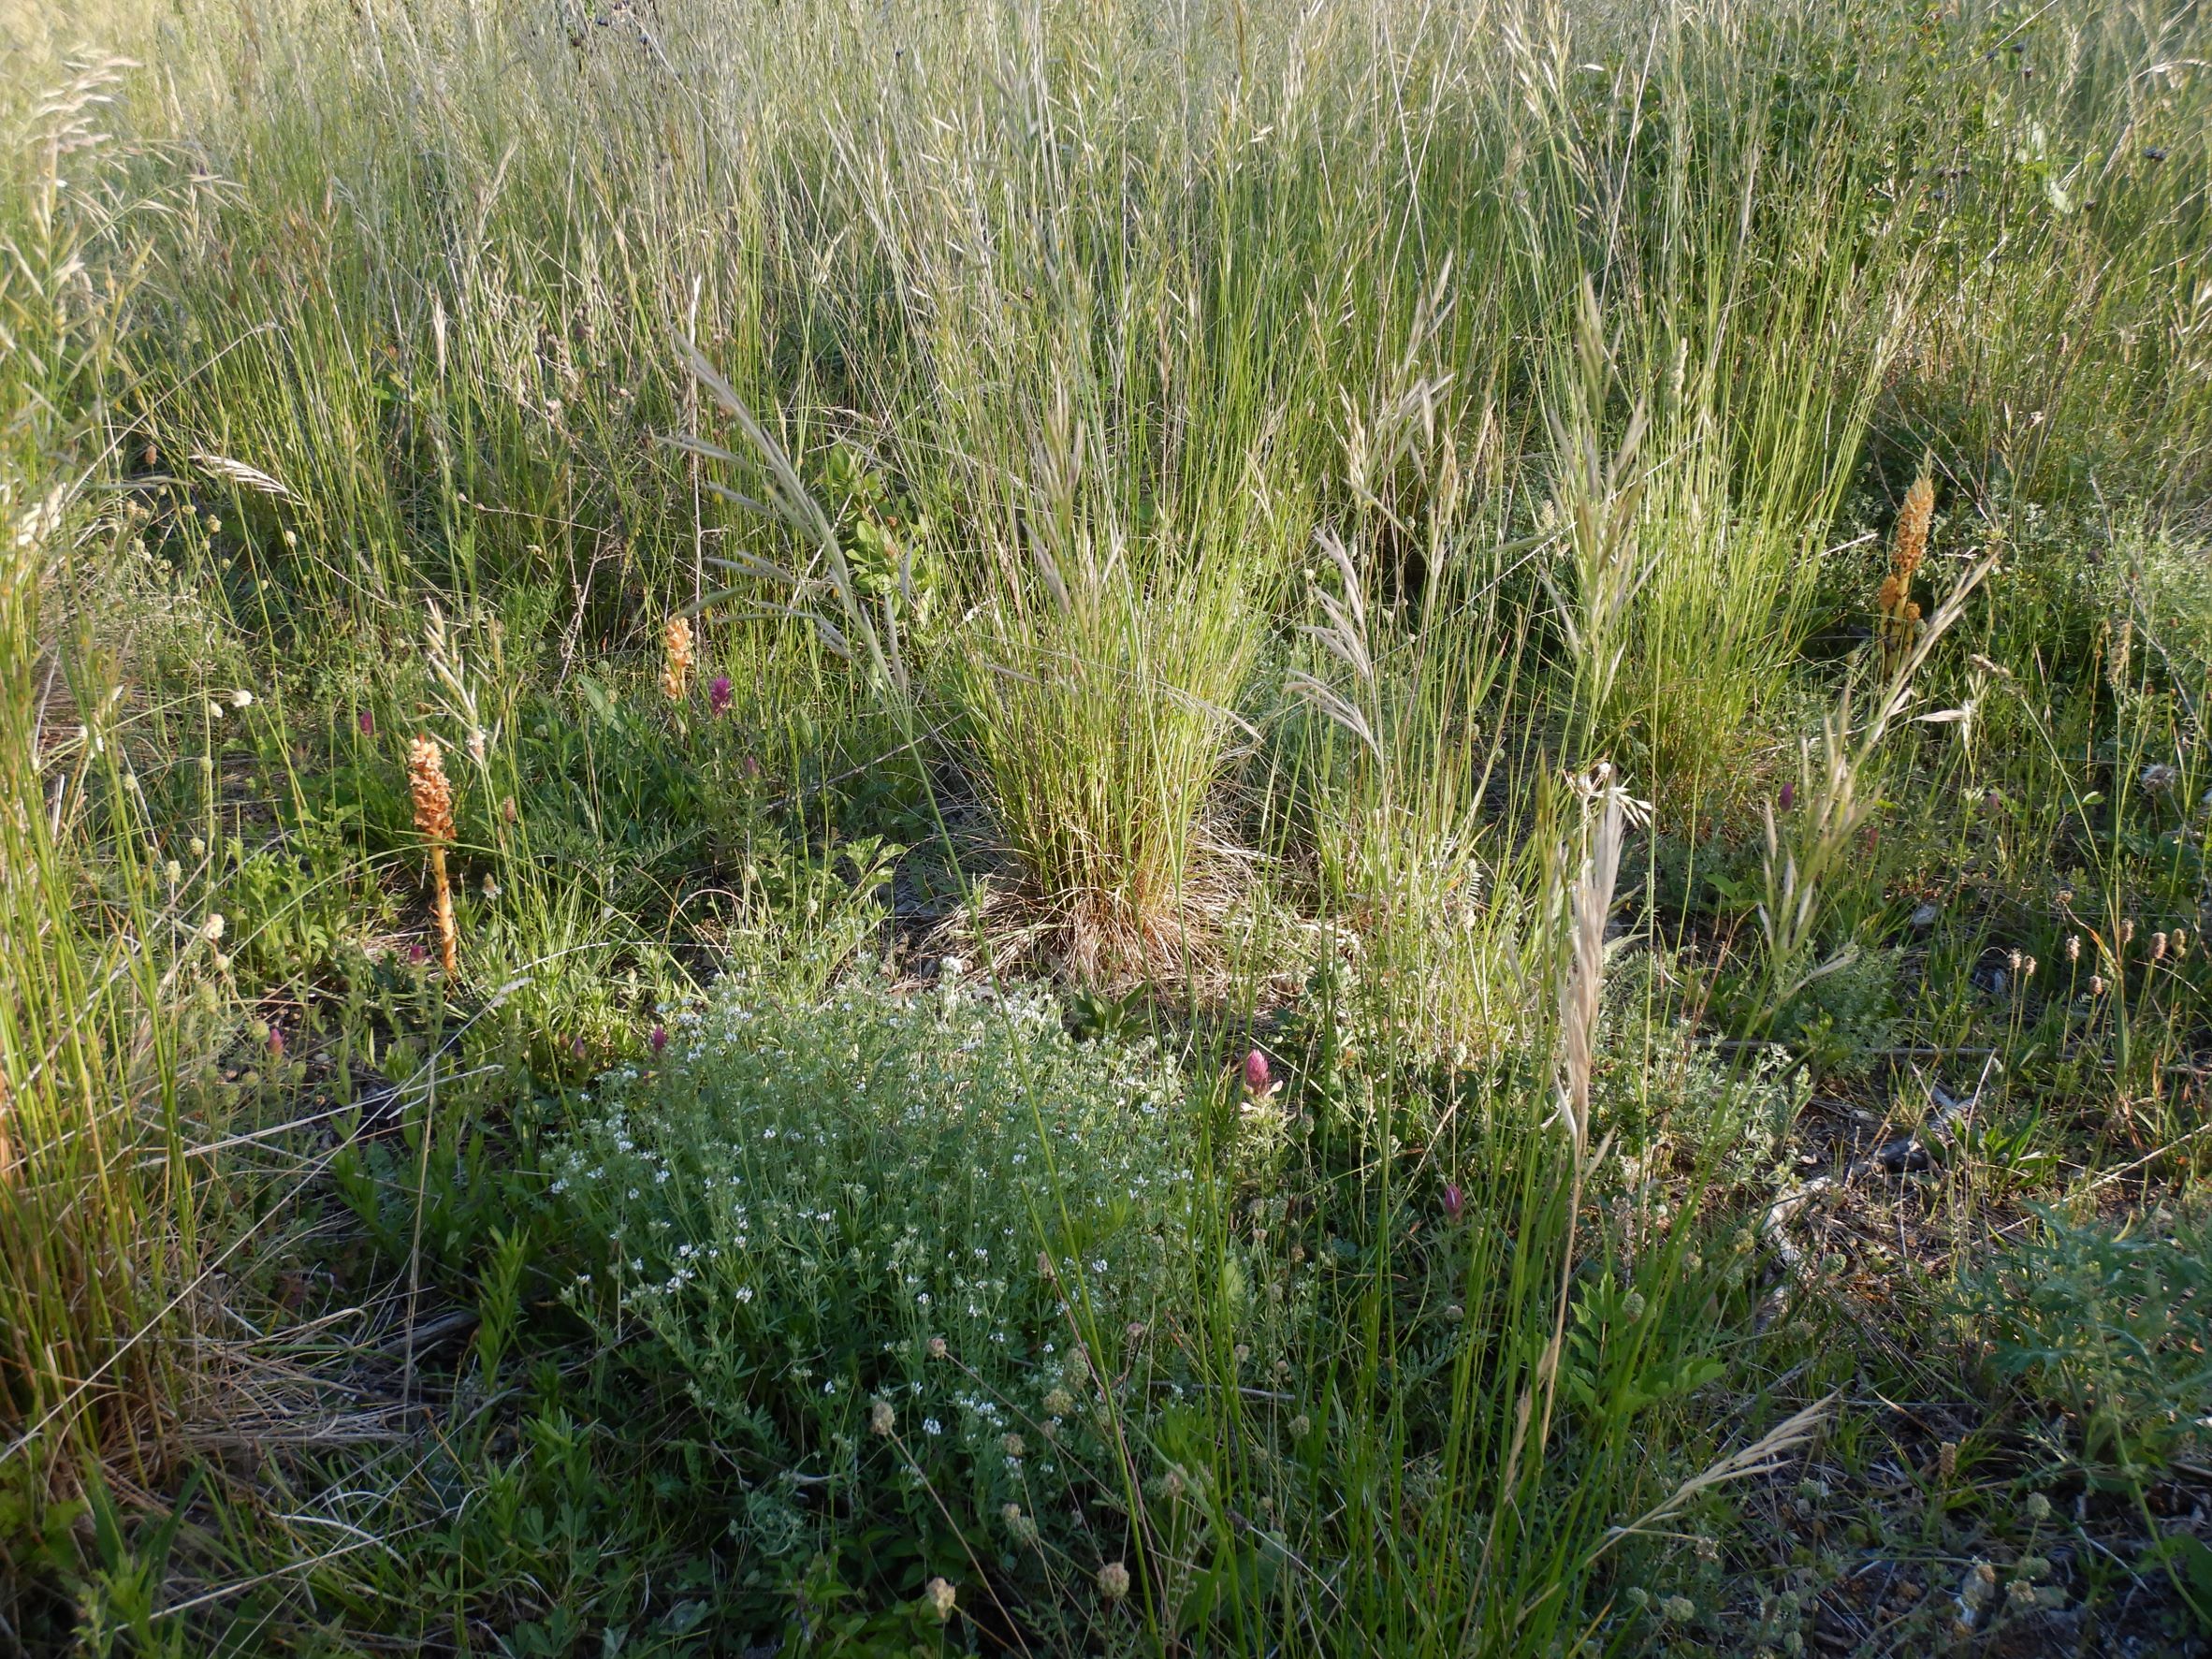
[548, 978, 1195, 1594]
